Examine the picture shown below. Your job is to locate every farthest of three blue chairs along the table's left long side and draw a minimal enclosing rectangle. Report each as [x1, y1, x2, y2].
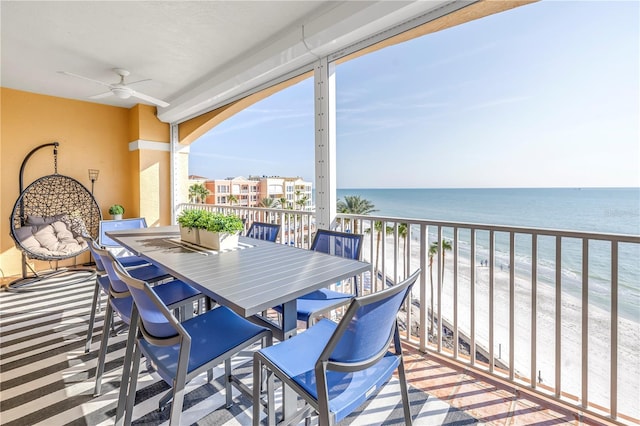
[83, 235, 178, 353]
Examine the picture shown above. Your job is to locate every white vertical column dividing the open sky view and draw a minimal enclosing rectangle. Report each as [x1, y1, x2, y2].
[314, 57, 336, 229]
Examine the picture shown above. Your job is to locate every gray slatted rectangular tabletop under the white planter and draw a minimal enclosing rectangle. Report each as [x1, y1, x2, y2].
[107, 226, 371, 338]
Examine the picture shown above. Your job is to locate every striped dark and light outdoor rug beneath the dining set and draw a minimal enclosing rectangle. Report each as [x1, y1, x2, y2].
[0, 282, 477, 426]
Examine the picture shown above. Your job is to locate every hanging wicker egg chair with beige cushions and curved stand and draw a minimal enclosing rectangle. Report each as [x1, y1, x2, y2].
[9, 142, 102, 290]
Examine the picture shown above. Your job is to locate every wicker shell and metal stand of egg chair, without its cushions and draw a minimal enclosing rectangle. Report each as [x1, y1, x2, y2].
[8, 142, 102, 291]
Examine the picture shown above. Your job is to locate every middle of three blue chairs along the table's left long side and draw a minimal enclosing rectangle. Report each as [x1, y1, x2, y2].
[94, 248, 203, 396]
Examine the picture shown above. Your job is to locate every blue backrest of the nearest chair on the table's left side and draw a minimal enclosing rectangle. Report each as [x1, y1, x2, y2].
[114, 263, 182, 345]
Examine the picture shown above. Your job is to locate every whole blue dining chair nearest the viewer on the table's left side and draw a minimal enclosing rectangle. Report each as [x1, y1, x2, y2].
[115, 256, 273, 425]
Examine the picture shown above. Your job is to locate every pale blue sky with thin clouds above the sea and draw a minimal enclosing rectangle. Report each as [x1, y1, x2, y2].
[189, 1, 640, 188]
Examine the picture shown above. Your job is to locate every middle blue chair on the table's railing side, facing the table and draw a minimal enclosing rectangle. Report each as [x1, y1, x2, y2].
[274, 229, 362, 328]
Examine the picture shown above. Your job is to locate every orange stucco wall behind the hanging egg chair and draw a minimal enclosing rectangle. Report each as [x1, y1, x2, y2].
[0, 88, 170, 276]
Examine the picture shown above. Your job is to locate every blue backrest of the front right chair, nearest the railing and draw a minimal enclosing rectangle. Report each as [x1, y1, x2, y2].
[318, 269, 420, 371]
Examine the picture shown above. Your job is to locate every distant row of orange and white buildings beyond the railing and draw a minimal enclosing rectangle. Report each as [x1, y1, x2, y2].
[193, 176, 313, 210]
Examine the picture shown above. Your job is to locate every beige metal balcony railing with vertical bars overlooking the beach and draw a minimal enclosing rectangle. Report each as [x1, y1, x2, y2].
[179, 204, 640, 423]
